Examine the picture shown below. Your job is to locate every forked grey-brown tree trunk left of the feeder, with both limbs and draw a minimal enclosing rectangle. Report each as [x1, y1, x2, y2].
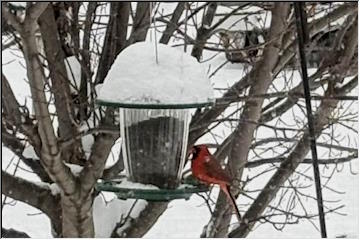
[2, 3, 113, 237]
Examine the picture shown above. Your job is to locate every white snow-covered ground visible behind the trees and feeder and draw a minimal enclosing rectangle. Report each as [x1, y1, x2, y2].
[1, 4, 359, 239]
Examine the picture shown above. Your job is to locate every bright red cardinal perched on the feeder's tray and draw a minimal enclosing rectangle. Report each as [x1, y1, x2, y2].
[190, 145, 241, 222]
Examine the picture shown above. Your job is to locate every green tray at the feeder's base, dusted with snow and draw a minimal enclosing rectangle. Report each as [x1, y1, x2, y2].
[96, 176, 209, 201]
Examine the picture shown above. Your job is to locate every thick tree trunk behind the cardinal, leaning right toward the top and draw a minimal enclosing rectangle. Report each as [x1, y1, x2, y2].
[202, 3, 290, 237]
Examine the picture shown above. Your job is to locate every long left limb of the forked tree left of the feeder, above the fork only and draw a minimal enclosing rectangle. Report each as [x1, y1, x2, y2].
[20, 9, 75, 194]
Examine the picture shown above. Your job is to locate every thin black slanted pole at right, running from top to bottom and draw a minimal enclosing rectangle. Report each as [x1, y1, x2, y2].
[294, 2, 327, 238]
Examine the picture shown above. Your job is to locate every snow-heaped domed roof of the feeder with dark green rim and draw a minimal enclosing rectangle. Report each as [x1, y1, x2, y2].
[97, 42, 214, 108]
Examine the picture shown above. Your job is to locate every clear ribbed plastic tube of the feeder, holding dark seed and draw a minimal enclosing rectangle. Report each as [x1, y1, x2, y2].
[120, 108, 190, 189]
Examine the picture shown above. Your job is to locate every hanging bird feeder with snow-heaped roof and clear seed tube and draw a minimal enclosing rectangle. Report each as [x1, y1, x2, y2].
[96, 42, 213, 200]
